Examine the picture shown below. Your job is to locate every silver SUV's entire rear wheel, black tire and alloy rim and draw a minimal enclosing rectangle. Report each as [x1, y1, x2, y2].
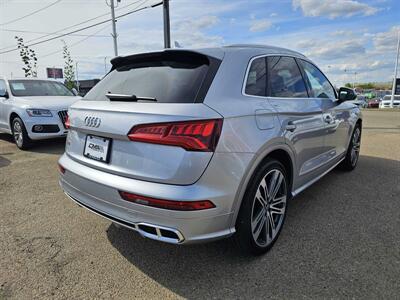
[235, 159, 289, 255]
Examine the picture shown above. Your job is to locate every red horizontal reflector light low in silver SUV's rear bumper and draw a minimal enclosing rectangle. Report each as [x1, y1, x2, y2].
[119, 191, 215, 211]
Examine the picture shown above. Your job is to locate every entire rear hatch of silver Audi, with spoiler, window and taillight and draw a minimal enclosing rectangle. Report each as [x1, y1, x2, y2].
[66, 50, 222, 185]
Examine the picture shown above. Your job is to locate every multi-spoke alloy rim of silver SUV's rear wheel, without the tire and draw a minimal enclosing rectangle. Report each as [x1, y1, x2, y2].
[251, 169, 287, 247]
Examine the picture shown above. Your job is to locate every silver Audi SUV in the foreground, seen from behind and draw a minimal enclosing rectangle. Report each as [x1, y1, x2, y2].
[59, 45, 362, 254]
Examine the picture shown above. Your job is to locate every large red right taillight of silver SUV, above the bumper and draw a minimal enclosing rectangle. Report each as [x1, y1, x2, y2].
[128, 119, 222, 152]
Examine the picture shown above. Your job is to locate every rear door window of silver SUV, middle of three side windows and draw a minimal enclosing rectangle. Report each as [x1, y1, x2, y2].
[267, 56, 308, 98]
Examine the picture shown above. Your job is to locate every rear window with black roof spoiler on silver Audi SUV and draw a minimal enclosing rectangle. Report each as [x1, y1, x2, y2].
[84, 52, 214, 103]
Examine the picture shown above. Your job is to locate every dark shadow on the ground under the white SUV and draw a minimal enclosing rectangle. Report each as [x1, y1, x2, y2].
[0, 133, 65, 155]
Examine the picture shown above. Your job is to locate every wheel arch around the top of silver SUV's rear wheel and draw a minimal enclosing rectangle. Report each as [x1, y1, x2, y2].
[231, 144, 295, 227]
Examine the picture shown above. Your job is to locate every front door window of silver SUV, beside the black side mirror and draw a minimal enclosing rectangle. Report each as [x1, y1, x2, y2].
[300, 60, 336, 99]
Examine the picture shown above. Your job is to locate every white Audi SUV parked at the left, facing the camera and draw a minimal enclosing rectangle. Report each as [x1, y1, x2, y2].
[0, 77, 81, 149]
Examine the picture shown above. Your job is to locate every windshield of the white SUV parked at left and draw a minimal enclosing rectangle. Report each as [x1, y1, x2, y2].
[9, 79, 74, 97]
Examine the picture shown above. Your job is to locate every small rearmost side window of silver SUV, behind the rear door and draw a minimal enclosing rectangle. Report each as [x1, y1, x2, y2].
[245, 57, 267, 97]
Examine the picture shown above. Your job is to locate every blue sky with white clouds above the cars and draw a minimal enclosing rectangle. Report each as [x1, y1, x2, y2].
[0, 0, 400, 85]
